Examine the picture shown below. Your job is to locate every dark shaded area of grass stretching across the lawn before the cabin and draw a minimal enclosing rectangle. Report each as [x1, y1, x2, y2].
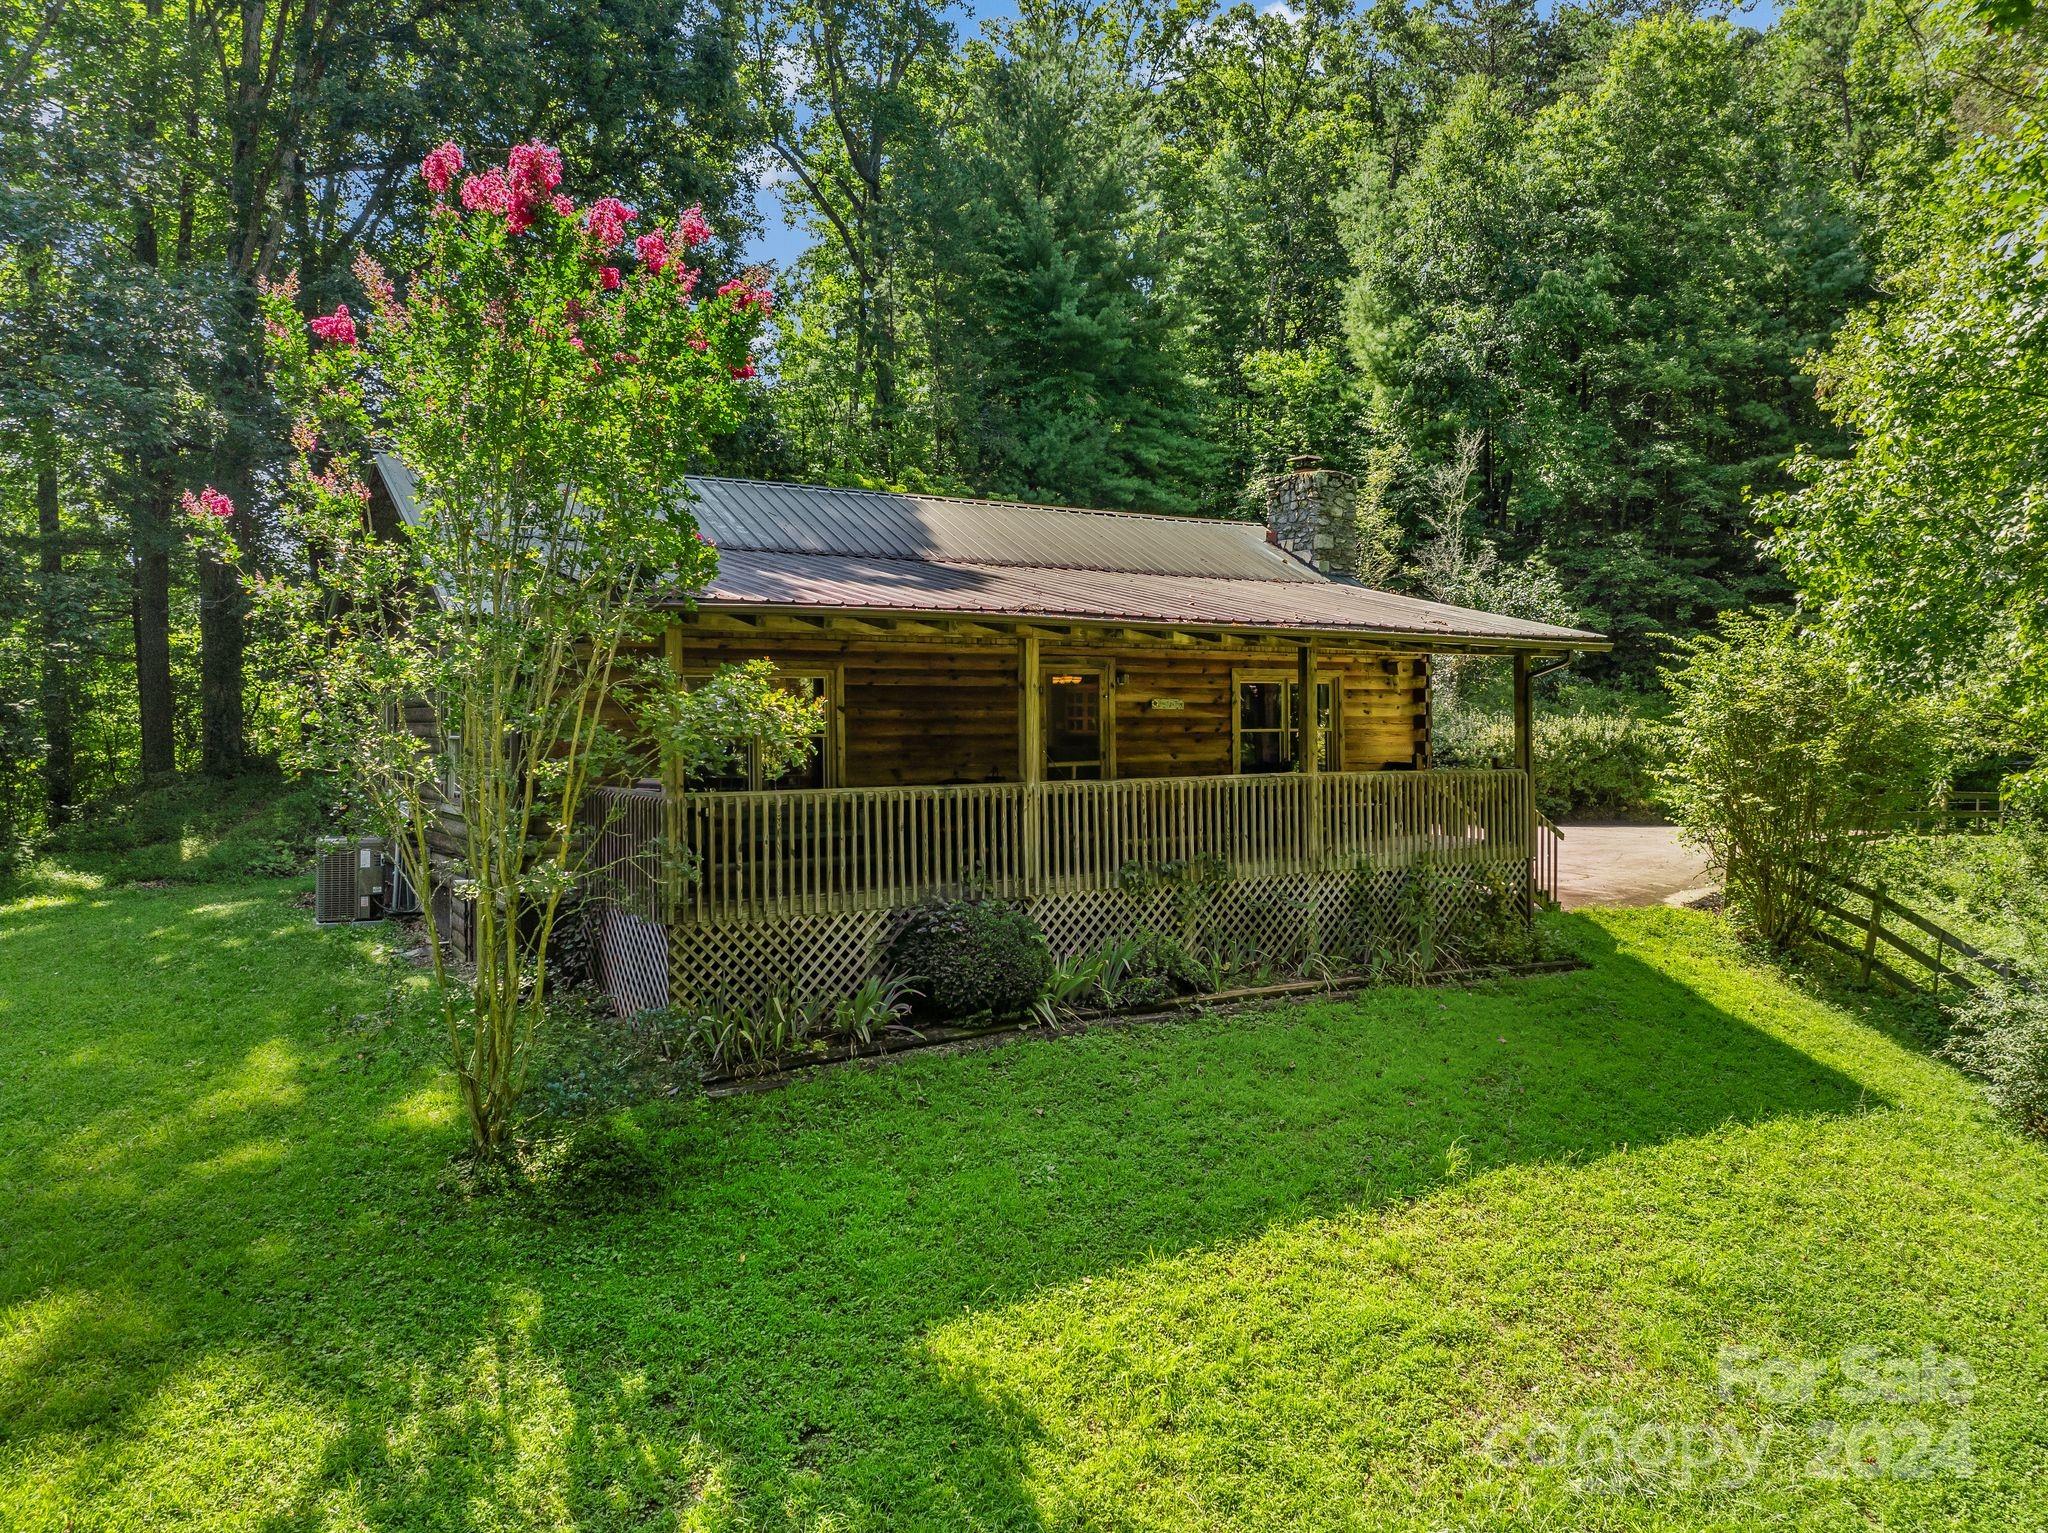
[0, 904, 1882, 1527]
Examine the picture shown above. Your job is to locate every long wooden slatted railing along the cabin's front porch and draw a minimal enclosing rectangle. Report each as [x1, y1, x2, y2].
[594, 770, 1534, 925]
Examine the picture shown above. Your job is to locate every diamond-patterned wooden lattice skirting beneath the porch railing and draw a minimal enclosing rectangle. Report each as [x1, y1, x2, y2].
[598, 866, 1528, 1015]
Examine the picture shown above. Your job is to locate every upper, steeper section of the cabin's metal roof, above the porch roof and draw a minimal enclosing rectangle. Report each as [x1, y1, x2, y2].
[690, 477, 1317, 583]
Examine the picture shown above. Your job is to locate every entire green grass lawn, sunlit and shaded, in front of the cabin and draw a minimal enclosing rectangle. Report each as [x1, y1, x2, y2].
[0, 880, 2048, 1529]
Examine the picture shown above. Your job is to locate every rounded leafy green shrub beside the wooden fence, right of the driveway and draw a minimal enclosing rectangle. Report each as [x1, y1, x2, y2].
[1663, 614, 1939, 948]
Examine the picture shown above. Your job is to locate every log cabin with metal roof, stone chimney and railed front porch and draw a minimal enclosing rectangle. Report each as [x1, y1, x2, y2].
[381, 448, 1608, 1011]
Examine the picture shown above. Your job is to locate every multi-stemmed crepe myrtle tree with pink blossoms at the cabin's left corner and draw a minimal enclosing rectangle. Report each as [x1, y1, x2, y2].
[188, 143, 821, 1156]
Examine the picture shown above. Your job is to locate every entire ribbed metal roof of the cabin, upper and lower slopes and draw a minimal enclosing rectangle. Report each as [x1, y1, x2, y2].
[377, 454, 1608, 649]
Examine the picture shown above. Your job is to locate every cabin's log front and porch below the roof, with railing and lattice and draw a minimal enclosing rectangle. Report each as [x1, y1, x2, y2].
[592, 626, 1544, 1011]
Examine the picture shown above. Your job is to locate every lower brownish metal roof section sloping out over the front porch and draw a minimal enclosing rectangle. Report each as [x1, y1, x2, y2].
[698, 549, 1606, 649]
